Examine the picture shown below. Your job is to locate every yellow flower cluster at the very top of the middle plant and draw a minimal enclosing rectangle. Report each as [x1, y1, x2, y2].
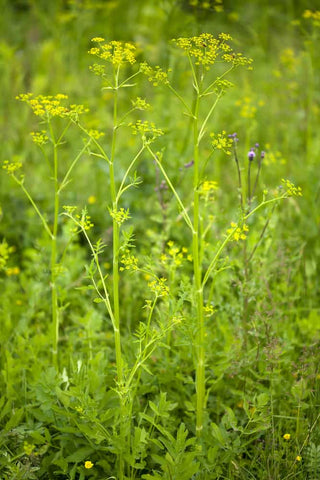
[89, 37, 136, 67]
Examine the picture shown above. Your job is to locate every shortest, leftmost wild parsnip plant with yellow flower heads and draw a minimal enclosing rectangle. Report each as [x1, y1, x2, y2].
[3, 93, 90, 365]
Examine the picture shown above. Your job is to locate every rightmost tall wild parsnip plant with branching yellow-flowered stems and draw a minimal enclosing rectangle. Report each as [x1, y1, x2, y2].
[142, 33, 300, 437]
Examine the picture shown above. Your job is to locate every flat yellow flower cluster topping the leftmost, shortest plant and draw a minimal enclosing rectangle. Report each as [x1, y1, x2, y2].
[16, 93, 88, 117]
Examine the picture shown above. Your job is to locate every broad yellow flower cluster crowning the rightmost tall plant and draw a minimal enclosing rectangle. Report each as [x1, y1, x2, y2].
[173, 33, 252, 70]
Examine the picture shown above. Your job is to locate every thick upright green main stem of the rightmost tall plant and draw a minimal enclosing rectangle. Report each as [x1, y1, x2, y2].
[192, 92, 205, 436]
